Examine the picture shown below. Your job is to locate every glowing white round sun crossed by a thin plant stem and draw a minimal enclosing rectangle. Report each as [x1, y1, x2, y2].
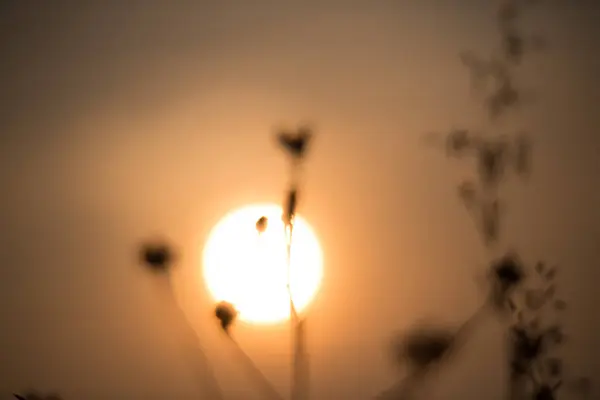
[203, 204, 323, 324]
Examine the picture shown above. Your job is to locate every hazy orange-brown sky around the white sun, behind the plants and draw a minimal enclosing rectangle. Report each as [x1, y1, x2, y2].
[0, 0, 600, 400]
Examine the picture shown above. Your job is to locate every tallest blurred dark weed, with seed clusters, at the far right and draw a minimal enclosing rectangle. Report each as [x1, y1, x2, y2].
[422, 0, 589, 400]
